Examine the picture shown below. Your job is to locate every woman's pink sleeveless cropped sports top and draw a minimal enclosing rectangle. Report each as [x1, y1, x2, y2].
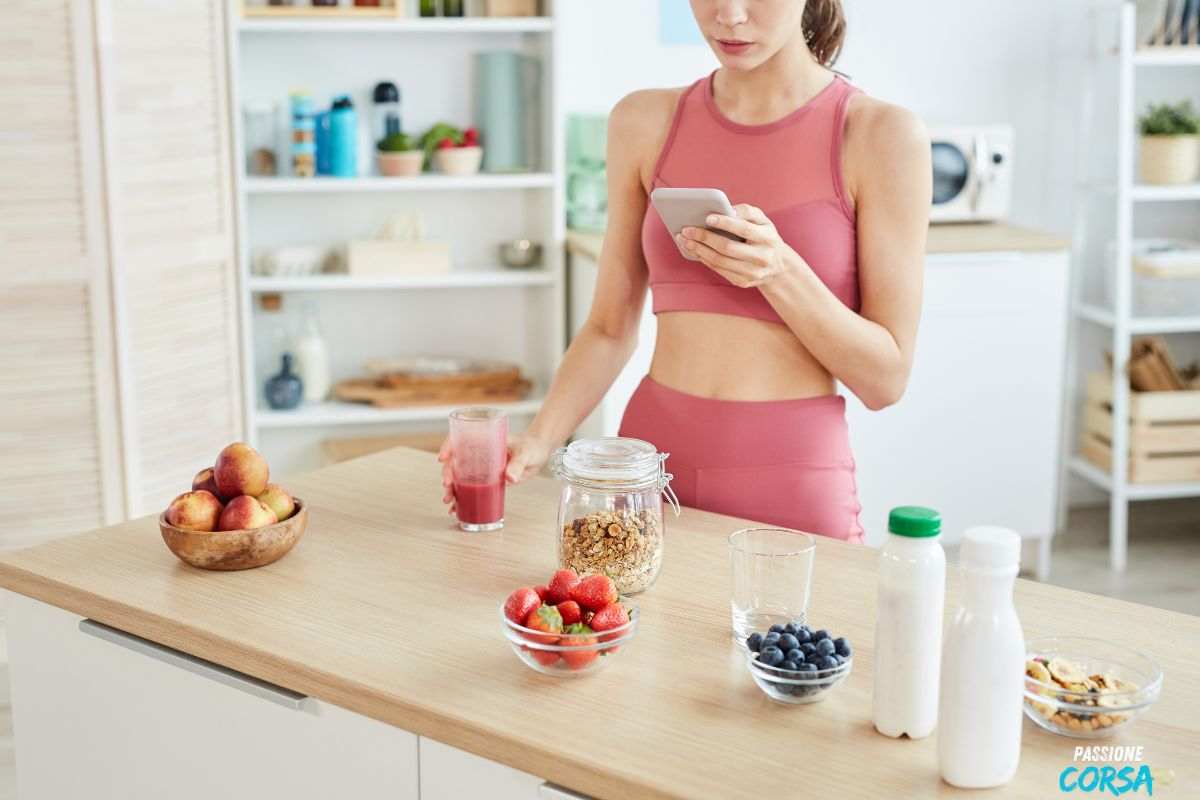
[642, 73, 859, 323]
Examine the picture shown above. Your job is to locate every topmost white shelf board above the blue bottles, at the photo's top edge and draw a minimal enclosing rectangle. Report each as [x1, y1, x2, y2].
[238, 14, 554, 34]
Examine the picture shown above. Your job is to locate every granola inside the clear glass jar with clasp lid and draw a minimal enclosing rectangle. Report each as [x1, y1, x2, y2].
[558, 510, 662, 595]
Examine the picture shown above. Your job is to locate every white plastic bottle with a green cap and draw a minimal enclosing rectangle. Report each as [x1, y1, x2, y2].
[871, 506, 946, 739]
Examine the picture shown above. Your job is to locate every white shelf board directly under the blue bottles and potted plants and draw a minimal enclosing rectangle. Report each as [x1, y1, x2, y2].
[242, 173, 554, 194]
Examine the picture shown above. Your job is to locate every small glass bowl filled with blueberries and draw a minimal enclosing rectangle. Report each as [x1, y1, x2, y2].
[745, 622, 854, 704]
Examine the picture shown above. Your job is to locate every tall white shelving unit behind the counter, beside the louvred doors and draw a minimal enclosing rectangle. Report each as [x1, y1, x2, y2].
[226, 0, 565, 473]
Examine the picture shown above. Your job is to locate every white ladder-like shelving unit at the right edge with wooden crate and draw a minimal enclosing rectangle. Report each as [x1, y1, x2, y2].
[1067, 0, 1200, 572]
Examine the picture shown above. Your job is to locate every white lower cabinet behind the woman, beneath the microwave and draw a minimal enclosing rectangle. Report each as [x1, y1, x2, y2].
[570, 244, 1069, 577]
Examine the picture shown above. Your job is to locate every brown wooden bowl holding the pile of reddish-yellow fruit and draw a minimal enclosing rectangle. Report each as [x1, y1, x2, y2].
[158, 498, 308, 570]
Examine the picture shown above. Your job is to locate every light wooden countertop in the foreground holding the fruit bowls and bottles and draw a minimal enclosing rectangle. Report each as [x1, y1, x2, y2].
[0, 450, 1200, 800]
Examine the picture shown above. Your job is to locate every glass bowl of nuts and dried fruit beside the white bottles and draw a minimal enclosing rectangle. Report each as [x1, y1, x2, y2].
[1025, 636, 1163, 739]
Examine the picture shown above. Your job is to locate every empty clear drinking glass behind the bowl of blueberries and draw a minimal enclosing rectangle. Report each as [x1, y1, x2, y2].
[730, 528, 816, 644]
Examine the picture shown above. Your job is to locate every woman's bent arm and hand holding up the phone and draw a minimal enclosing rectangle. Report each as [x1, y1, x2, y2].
[683, 97, 932, 410]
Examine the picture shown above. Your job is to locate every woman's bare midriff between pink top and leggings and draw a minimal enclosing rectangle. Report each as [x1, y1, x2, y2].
[650, 311, 834, 401]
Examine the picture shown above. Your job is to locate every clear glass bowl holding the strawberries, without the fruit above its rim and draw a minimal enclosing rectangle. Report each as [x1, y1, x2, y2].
[500, 597, 637, 678]
